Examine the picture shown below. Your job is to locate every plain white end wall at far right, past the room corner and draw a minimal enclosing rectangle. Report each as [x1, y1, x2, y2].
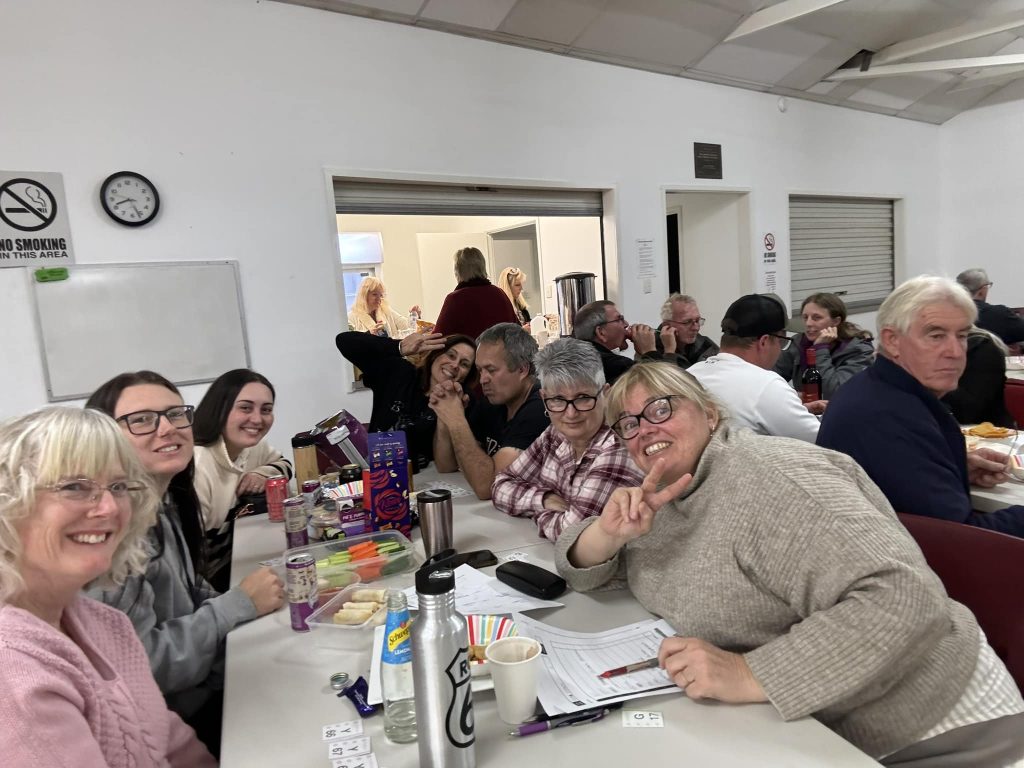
[935, 83, 1024, 306]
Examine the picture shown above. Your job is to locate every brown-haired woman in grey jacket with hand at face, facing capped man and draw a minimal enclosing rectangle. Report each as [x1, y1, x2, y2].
[774, 293, 874, 400]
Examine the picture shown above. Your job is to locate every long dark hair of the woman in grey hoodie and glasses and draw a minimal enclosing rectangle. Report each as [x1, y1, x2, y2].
[85, 371, 206, 587]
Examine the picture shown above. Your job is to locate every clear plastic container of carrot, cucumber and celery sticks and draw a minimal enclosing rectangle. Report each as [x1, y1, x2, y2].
[285, 530, 423, 605]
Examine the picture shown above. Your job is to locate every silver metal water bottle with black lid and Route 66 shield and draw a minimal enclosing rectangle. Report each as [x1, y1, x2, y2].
[412, 566, 476, 768]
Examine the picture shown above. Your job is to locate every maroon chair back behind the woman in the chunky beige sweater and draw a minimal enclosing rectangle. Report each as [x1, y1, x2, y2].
[898, 512, 1024, 690]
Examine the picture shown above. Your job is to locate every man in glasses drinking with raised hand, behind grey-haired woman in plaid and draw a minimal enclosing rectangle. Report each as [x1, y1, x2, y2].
[572, 299, 675, 385]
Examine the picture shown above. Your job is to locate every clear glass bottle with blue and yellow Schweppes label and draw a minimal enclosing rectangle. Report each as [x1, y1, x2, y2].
[381, 590, 416, 743]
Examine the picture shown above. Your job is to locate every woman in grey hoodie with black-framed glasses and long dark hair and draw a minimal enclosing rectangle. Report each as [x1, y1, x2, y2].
[85, 371, 284, 755]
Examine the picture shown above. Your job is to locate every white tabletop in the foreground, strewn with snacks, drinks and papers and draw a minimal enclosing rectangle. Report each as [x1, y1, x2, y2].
[221, 474, 877, 768]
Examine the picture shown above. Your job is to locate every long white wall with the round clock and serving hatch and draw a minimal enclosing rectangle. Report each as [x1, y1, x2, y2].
[0, 0, 943, 446]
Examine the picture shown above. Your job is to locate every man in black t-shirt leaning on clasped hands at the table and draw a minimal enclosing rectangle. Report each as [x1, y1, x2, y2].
[430, 323, 550, 499]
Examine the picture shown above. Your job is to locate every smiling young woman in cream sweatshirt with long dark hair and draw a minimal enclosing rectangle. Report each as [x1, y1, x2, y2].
[193, 368, 292, 592]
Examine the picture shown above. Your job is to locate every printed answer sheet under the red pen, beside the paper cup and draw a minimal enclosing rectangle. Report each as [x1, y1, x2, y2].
[513, 614, 678, 715]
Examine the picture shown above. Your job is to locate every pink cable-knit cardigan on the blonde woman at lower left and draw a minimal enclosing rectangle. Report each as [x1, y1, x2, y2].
[0, 596, 216, 768]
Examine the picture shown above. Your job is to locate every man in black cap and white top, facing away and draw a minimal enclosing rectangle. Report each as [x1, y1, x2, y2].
[687, 294, 818, 442]
